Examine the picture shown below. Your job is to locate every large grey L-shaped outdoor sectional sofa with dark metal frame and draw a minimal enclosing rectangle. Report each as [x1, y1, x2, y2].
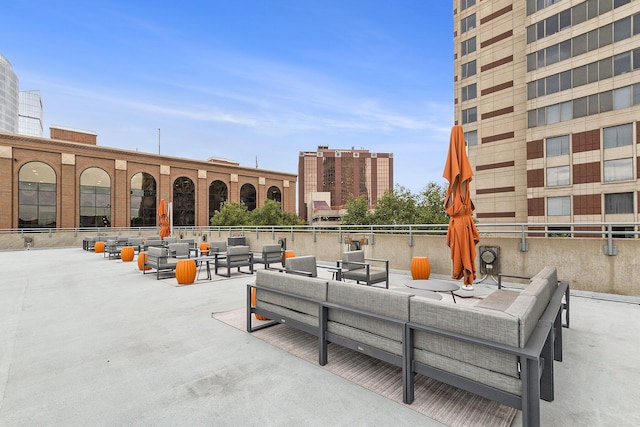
[247, 267, 569, 426]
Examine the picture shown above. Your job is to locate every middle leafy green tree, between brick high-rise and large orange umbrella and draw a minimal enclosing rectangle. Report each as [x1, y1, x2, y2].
[373, 184, 419, 224]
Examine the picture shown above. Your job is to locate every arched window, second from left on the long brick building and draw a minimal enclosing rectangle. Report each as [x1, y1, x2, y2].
[80, 168, 111, 227]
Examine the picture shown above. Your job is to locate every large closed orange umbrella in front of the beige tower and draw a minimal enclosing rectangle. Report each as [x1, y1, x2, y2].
[442, 126, 480, 290]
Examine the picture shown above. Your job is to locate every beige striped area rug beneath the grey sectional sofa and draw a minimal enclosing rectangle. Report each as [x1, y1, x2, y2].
[213, 309, 517, 427]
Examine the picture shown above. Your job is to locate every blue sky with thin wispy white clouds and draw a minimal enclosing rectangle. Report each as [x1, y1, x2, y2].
[0, 0, 453, 193]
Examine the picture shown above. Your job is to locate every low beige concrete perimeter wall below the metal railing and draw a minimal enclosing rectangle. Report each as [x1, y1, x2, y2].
[0, 231, 640, 296]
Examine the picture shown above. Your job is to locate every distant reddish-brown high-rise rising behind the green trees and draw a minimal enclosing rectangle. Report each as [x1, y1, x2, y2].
[298, 146, 393, 221]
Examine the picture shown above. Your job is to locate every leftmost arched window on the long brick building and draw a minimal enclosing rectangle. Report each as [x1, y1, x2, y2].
[18, 162, 57, 228]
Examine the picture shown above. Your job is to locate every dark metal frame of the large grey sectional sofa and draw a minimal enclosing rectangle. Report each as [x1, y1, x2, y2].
[247, 281, 569, 427]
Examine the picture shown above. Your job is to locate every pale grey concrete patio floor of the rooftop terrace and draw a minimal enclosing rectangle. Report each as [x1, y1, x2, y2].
[0, 248, 640, 426]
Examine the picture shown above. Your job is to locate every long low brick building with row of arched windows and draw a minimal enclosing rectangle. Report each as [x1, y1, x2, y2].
[0, 127, 296, 229]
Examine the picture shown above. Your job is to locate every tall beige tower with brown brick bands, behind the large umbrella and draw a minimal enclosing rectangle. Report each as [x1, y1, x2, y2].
[453, 0, 640, 231]
